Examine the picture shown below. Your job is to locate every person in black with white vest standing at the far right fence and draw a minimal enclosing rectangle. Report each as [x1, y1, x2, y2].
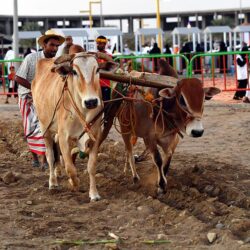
[233, 46, 248, 100]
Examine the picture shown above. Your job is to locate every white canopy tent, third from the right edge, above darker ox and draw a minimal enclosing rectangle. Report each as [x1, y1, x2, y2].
[172, 27, 201, 51]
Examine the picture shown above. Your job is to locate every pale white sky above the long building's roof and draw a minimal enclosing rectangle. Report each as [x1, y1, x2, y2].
[0, 0, 250, 16]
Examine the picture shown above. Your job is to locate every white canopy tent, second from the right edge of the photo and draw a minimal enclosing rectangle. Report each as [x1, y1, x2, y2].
[203, 26, 232, 52]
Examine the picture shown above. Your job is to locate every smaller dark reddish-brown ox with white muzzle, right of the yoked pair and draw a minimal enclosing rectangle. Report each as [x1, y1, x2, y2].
[118, 78, 219, 194]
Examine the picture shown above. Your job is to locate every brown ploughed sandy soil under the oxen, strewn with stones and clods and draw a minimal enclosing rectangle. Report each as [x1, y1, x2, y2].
[0, 96, 250, 250]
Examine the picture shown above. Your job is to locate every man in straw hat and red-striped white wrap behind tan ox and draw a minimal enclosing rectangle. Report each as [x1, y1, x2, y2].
[15, 30, 65, 168]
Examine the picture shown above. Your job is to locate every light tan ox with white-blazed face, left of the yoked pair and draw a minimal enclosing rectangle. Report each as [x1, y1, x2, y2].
[32, 53, 111, 200]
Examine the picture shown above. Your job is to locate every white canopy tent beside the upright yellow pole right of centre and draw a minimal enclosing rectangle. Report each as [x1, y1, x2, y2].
[135, 28, 163, 54]
